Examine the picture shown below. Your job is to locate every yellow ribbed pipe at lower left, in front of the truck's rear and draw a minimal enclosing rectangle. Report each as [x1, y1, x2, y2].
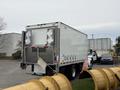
[3, 74, 72, 90]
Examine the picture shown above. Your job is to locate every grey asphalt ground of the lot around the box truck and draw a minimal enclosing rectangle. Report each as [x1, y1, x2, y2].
[0, 60, 120, 90]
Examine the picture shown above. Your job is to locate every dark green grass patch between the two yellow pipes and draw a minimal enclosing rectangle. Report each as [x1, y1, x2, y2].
[72, 78, 94, 90]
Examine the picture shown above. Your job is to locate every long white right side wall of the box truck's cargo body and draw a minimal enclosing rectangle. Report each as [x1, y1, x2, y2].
[60, 24, 88, 63]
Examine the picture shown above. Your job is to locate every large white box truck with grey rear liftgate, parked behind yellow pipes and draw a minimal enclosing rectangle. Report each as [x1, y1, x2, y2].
[21, 22, 88, 79]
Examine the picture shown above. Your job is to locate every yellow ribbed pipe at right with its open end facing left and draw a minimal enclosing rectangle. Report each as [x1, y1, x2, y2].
[83, 67, 120, 90]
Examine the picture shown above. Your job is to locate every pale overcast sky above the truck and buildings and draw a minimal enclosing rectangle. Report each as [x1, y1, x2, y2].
[0, 0, 120, 42]
